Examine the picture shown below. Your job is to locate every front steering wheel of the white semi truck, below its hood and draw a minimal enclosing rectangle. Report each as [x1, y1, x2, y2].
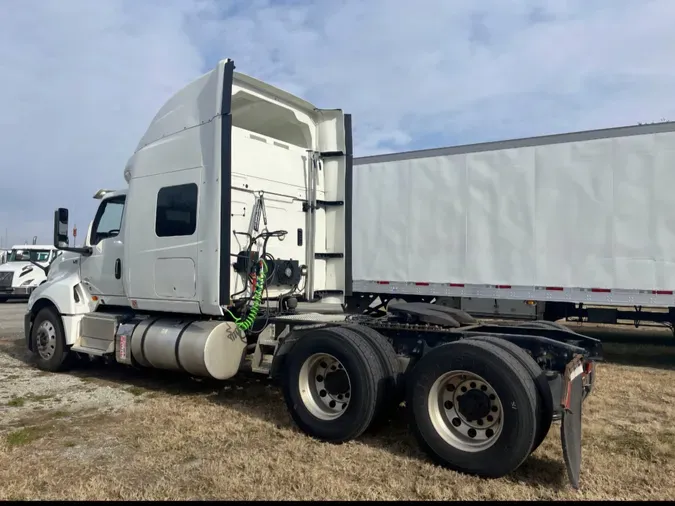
[31, 307, 72, 372]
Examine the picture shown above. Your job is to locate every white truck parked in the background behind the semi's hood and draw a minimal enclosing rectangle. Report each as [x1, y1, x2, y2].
[0, 244, 61, 302]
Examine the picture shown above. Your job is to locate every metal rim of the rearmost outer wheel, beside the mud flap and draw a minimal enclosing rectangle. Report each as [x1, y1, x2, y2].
[428, 371, 504, 452]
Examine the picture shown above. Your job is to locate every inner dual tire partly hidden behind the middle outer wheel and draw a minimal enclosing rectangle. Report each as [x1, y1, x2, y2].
[343, 325, 405, 425]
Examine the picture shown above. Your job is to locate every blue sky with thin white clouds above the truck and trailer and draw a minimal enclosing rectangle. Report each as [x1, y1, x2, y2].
[0, 0, 675, 242]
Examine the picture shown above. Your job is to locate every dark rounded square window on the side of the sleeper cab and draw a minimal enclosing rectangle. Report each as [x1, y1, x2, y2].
[155, 183, 198, 237]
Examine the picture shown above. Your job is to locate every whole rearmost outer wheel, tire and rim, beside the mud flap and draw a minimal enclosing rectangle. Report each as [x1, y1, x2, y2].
[407, 340, 537, 478]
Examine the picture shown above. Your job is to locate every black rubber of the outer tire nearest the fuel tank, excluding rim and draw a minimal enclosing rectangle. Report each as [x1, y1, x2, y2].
[282, 327, 385, 443]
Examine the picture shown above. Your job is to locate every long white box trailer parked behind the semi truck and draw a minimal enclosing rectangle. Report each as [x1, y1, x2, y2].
[349, 122, 675, 325]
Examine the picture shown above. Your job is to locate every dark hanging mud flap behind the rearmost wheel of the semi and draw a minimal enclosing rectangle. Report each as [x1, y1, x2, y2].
[560, 355, 584, 489]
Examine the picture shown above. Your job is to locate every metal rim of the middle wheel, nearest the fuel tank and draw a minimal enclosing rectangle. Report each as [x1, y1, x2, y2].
[299, 353, 352, 420]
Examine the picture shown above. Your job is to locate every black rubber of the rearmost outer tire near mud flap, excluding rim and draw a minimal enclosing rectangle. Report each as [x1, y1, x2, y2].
[407, 339, 537, 478]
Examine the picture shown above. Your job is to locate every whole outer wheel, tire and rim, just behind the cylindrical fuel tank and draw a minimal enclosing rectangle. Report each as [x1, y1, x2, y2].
[283, 328, 385, 443]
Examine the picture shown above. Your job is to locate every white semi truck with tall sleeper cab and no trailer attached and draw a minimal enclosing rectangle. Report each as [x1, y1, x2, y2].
[25, 60, 602, 486]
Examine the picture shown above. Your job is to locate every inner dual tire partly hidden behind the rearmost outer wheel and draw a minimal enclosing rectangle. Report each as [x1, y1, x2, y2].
[470, 336, 553, 453]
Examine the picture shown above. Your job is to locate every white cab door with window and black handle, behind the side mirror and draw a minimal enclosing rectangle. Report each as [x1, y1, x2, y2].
[80, 195, 128, 306]
